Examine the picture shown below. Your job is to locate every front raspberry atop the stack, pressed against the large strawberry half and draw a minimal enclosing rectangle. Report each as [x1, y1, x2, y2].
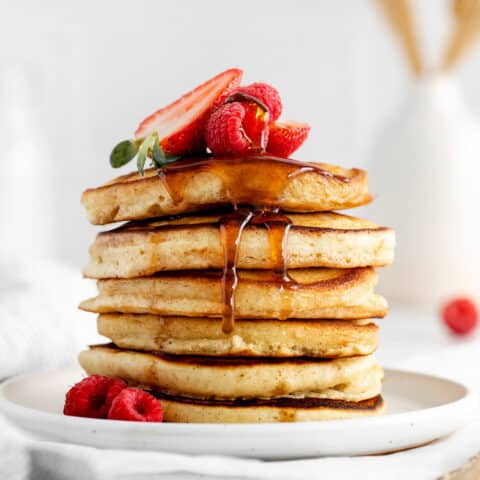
[205, 102, 252, 154]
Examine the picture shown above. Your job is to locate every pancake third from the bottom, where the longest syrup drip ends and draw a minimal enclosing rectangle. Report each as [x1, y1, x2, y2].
[97, 313, 378, 358]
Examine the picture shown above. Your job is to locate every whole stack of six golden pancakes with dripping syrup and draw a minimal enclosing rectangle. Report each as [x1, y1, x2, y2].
[80, 155, 395, 422]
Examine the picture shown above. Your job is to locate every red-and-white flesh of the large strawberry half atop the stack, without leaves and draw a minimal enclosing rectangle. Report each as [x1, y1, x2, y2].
[135, 68, 243, 155]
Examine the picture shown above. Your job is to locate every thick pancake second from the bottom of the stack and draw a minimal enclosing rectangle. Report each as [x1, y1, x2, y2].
[79, 344, 383, 402]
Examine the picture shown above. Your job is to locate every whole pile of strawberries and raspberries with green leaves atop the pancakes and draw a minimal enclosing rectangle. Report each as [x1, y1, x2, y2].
[110, 68, 310, 168]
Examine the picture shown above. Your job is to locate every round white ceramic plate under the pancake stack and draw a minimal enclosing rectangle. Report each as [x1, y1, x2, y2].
[0, 369, 477, 459]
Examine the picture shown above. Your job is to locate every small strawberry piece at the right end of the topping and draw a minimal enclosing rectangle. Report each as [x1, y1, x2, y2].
[267, 120, 310, 158]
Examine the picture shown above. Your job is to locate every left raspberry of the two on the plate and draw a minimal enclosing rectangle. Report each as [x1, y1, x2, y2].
[63, 375, 126, 418]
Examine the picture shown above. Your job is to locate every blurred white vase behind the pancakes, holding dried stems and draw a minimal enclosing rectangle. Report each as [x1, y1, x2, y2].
[368, 75, 480, 305]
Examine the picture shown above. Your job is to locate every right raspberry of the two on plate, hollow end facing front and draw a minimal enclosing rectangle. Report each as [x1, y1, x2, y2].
[108, 388, 163, 422]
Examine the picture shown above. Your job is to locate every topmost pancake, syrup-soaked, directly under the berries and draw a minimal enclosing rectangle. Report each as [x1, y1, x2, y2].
[82, 155, 371, 225]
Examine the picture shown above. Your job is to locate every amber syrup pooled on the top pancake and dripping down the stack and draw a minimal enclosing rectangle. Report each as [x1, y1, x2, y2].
[158, 155, 349, 333]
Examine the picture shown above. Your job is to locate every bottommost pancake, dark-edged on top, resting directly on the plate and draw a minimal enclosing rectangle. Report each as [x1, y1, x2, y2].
[152, 395, 385, 423]
